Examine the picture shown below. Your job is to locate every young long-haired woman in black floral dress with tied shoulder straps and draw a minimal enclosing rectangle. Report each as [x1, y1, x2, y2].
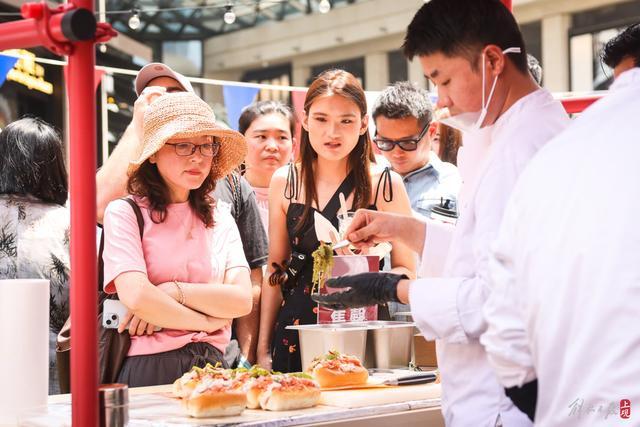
[258, 70, 415, 372]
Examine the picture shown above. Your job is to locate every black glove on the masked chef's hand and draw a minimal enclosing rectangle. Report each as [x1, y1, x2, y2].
[311, 273, 408, 310]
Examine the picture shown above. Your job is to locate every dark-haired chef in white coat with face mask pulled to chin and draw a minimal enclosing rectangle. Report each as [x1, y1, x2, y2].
[318, 0, 569, 427]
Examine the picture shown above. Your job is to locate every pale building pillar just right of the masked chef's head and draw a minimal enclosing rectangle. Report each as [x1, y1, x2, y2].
[542, 14, 571, 92]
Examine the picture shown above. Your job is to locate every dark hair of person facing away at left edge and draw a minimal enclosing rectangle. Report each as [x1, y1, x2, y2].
[0, 117, 69, 206]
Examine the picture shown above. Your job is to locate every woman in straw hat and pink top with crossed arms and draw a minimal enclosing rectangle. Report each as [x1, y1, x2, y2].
[103, 92, 252, 387]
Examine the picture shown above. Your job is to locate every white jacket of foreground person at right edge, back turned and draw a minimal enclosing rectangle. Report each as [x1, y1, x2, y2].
[481, 68, 640, 427]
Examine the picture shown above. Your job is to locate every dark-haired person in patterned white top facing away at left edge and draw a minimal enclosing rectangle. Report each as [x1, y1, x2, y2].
[0, 118, 71, 394]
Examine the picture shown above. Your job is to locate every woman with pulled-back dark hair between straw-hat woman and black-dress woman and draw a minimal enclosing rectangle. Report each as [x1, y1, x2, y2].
[238, 101, 296, 233]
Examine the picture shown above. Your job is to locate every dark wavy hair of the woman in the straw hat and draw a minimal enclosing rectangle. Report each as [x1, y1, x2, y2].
[127, 158, 216, 228]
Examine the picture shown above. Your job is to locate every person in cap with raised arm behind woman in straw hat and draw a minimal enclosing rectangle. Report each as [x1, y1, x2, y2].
[96, 62, 268, 367]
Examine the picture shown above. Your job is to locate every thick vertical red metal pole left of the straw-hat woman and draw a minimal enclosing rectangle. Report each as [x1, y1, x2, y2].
[67, 0, 98, 427]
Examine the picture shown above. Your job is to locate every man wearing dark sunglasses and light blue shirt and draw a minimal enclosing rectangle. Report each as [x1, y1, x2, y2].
[372, 82, 462, 218]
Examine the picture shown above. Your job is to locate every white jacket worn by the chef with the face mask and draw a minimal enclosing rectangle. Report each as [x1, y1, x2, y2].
[409, 89, 569, 427]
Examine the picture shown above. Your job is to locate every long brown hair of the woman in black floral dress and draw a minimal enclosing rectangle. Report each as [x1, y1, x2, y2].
[296, 70, 375, 231]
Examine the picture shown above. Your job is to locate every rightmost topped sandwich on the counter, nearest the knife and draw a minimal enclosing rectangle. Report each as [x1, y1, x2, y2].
[308, 350, 369, 388]
